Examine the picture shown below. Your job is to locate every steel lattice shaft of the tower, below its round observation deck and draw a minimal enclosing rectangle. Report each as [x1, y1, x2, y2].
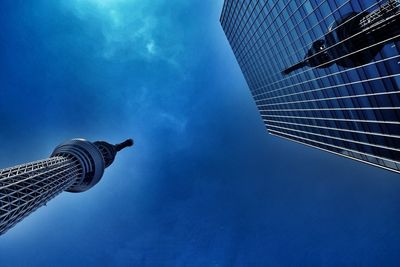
[0, 156, 82, 234]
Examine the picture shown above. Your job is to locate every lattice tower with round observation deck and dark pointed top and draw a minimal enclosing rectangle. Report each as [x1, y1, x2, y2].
[0, 139, 133, 235]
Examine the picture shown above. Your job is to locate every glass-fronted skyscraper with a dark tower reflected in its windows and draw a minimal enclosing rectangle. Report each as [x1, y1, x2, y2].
[220, 0, 400, 172]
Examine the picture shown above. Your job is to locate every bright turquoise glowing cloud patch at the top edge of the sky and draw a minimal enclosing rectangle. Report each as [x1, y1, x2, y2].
[64, 0, 182, 63]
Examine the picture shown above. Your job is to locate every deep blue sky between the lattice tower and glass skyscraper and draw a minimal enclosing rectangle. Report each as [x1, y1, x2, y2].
[0, 0, 400, 267]
